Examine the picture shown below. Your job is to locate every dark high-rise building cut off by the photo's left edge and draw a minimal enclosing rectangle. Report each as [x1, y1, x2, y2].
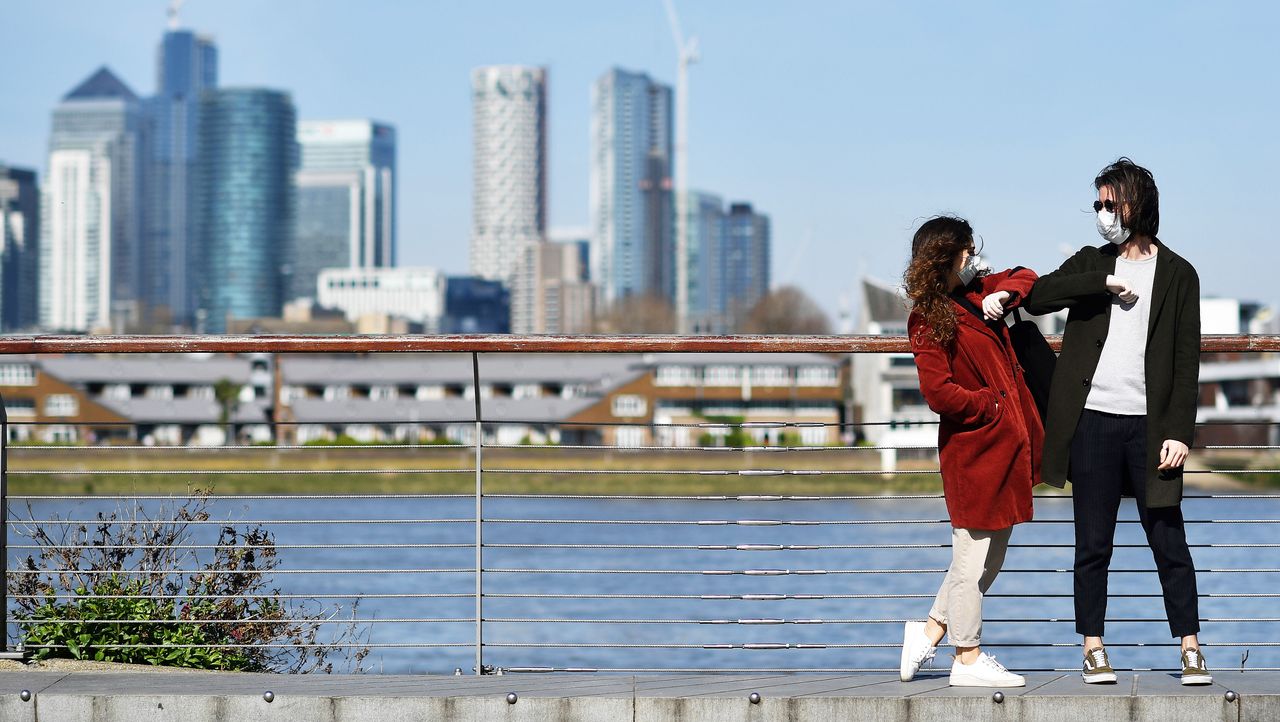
[0, 163, 40, 332]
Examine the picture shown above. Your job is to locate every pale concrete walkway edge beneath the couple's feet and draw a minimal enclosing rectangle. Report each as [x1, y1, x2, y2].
[0, 672, 1280, 722]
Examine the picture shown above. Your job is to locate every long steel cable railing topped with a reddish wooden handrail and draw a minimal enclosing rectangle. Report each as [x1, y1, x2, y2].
[0, 335, 1280, 673]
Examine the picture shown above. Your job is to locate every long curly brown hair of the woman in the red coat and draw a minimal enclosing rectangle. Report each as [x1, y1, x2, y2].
[902, 215, 975, 346]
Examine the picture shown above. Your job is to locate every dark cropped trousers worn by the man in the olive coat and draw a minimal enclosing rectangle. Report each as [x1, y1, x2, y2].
[1071, 408, 1199, 638]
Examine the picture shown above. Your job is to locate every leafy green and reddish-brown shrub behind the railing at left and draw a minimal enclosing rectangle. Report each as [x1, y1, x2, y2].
[9, 492, 369, 672]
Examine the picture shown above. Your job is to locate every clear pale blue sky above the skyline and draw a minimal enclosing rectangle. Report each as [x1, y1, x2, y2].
[0, 0, 1280, 325]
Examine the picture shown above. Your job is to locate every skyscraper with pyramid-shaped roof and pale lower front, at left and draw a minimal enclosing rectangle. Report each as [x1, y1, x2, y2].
[40, 68, 145, 332]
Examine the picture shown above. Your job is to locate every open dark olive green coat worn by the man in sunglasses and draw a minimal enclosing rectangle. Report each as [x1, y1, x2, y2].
[1023, 239, 1201, 508]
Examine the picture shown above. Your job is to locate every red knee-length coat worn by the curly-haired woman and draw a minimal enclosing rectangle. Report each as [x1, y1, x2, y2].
[908, 269, 1044, 530]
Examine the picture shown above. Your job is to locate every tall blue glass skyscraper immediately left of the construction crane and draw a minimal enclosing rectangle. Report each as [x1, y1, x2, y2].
[590, 68, 676, 309]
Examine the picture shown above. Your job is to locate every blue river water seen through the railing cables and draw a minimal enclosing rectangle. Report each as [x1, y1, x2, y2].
[10, 495, 1280, 673]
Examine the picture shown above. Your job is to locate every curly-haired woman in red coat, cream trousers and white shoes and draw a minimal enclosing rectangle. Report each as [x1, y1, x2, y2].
[900, 216, 1044, 687]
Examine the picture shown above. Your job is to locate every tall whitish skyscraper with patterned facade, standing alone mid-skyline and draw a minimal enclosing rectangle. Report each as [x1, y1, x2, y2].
[471, 65, 547, 283]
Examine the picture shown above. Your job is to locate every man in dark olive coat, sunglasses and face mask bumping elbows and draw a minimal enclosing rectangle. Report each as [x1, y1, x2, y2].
[1024, 157, 1212, 685]
